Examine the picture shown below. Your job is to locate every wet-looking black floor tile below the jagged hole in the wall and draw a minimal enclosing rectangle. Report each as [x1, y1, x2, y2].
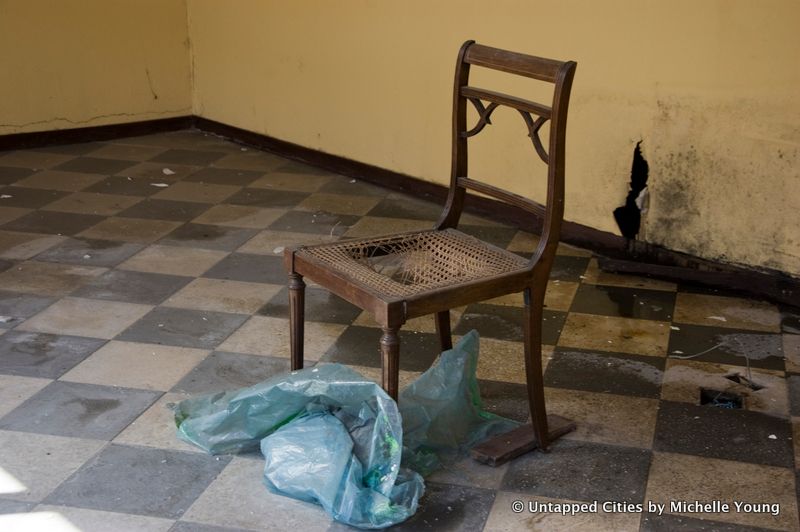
[570, 284, 675, 321]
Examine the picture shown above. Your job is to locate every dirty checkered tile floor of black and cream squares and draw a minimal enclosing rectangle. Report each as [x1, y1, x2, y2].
[0, 131, 800, 531]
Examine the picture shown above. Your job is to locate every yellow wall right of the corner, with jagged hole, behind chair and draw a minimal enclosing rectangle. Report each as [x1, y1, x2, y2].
[188, 0, 800, 275]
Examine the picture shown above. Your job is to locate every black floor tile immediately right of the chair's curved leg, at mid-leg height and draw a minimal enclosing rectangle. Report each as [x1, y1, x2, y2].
[544, 347, 665, 399]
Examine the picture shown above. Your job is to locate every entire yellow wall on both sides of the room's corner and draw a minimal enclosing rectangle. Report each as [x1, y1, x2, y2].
[0, 0, 800, 275]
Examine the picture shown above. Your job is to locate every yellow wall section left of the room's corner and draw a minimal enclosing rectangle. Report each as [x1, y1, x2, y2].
[0, 0, 191, 135]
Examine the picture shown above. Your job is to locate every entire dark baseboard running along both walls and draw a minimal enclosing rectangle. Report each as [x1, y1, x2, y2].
[0, 116, 800, 307]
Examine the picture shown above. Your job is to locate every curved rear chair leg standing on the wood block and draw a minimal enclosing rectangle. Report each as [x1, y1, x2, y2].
[524, 287, 550, 451]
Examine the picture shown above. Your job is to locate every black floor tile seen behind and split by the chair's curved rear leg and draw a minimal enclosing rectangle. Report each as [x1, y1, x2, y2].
[453, 303, 567, 345]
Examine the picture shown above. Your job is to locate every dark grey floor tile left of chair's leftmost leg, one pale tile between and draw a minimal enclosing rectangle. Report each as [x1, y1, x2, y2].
[118, 307, 248, 349]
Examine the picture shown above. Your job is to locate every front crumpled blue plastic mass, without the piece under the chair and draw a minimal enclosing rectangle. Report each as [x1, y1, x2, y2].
[175, 364, 425, 528]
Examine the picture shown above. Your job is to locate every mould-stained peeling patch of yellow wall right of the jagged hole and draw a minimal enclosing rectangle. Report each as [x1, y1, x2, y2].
[646, 98, 800, 276]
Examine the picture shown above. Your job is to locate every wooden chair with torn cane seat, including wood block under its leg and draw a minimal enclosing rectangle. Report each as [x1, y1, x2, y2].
[284, 41, 576, 463]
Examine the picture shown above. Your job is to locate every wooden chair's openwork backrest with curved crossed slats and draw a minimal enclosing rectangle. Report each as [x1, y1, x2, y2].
[437, 41, 576, 274]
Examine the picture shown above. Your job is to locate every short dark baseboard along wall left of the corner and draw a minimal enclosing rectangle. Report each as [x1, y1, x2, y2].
[0, 115, 194, 151]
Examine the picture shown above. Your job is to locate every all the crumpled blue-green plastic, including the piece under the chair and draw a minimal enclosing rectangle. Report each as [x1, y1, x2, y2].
[174, 331, 519, 528]
